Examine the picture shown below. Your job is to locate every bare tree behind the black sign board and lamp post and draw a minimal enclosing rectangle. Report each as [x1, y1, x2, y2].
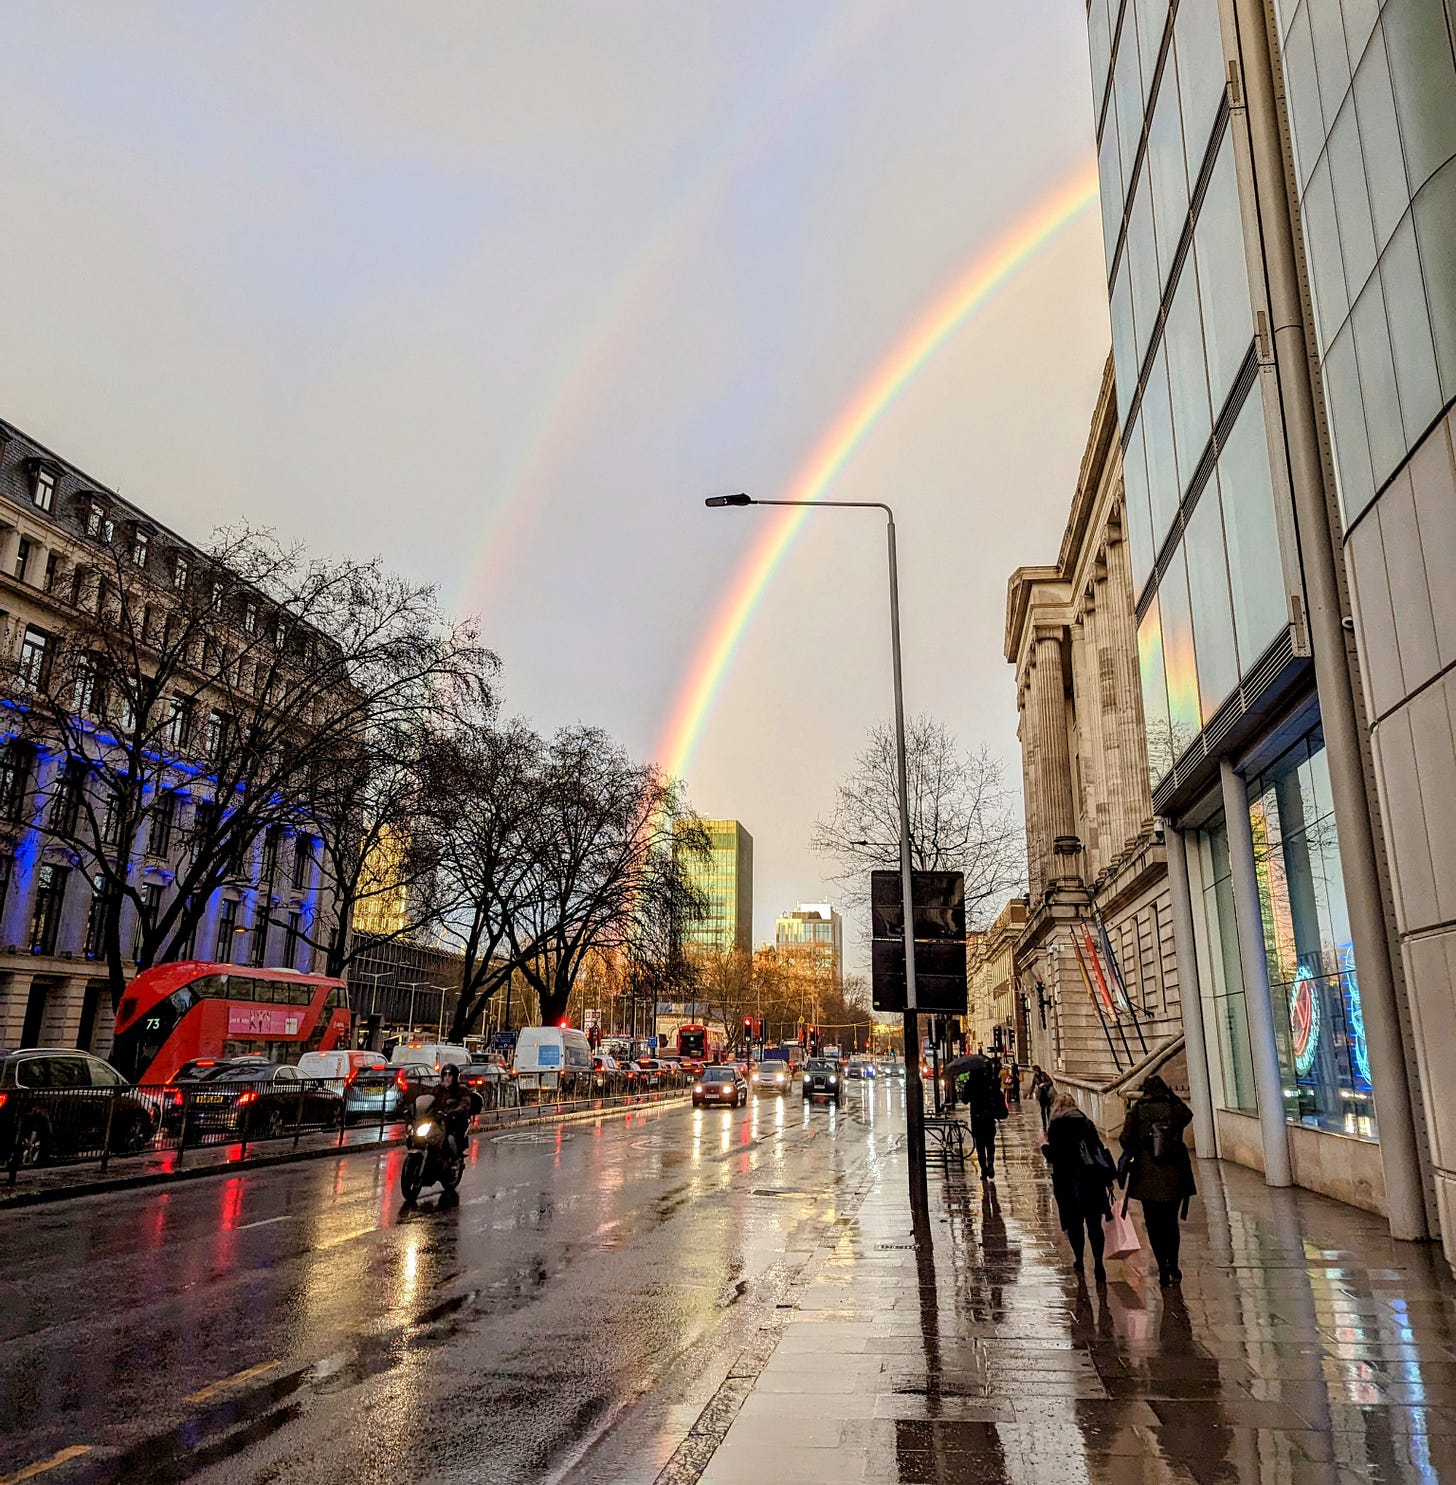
[811, 716, 1027, 924]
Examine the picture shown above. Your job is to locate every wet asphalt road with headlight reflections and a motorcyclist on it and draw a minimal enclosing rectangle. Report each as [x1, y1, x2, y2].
[0, 1084, 903, 1485]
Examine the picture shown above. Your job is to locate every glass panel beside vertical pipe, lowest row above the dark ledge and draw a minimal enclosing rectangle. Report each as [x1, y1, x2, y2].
[1218, 388, 1290, 674]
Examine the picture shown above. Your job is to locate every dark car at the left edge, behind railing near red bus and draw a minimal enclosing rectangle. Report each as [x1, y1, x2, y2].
[0, 1047, 157, 1169]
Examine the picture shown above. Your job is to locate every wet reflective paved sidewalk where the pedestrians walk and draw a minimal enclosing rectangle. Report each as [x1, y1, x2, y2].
[700, 1109, 1456, 1485]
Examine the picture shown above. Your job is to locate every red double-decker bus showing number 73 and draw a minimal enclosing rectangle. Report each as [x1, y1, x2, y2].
[111, 959, 349, 1083]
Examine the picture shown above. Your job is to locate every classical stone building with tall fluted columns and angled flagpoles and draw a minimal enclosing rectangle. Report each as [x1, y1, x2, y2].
[1006, 359, 1186, 1126]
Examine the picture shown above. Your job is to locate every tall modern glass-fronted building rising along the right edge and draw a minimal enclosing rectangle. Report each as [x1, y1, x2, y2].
[1088, 0, 1456, 1227]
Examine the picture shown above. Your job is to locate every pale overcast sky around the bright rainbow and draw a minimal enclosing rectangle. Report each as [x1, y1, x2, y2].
[0, 0, 1108, 962]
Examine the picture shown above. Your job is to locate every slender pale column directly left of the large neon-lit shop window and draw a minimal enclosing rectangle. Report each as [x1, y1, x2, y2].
[1218, 759, 1294, 1187]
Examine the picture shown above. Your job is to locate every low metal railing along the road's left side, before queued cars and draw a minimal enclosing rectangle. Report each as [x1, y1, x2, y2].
[0, 1069, 692, 1187]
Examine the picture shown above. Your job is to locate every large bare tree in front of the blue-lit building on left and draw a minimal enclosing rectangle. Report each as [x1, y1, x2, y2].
[7, 526, 493, 1002]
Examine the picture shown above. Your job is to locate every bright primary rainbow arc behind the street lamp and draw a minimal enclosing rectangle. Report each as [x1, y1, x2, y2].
[657, 160, 1096, 778]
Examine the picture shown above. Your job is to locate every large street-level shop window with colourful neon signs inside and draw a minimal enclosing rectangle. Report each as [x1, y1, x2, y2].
[1249, 728, 1377, 1139]
